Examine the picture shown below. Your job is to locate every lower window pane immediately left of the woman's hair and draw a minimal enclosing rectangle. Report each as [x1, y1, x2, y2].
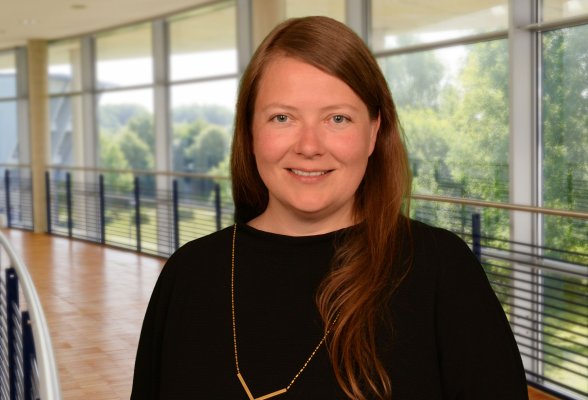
[171, 79, 237, 176]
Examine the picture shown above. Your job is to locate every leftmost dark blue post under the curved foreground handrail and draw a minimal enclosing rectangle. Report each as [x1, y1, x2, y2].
[6, 268, 20, 400]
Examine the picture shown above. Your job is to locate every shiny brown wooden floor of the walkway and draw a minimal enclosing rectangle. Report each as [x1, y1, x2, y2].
[2, 230, 553, 400]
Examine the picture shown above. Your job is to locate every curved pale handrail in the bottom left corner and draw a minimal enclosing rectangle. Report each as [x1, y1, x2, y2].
[0, 232, 61, 400]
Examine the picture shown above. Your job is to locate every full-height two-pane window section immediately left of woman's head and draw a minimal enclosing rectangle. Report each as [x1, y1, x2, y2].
[169, 2, 238, 176]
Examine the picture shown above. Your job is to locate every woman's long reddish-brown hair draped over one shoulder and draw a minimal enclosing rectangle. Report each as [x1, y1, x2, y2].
[231, 17, 410, 400]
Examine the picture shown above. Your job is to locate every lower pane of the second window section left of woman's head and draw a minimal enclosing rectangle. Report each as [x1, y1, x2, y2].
[98, 89, 155, 171]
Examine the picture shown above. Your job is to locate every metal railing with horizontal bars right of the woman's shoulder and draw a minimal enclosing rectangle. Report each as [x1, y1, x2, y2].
[412, 196, 588, 399]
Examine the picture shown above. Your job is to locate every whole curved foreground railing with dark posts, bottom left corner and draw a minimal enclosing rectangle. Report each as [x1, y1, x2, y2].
[0, 232, 61, 400]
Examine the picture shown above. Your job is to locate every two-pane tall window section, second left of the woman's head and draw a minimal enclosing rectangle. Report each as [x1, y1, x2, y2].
[95, 24, 155, 173]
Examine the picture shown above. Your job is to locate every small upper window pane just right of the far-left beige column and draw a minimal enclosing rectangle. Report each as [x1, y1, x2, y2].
[48, 40, 82, 94]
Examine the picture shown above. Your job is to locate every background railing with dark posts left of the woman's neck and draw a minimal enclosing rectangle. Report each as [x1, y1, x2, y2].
[45, 169, 233, 257]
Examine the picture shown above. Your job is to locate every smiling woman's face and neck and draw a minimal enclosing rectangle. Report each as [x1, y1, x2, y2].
[253, 57, 379, 231]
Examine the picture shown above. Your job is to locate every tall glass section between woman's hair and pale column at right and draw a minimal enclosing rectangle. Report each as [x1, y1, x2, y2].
[372, 0, 509, 239]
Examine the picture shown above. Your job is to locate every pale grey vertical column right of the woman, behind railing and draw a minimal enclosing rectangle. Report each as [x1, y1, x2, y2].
[509, 0, 541, 373]
